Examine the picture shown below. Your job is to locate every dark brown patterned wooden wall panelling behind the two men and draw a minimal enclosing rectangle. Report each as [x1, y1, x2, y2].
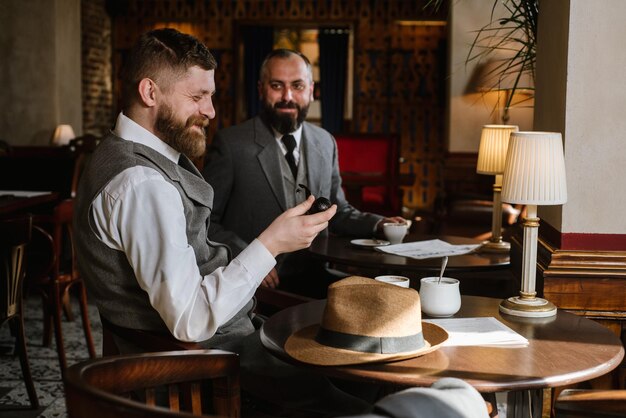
[109, 0, 447, 209]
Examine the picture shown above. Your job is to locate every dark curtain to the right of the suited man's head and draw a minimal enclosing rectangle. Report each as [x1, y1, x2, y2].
[318, 28, 350, 133]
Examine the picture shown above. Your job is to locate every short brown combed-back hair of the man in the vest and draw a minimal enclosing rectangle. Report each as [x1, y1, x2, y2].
[120, 28, 217, 109]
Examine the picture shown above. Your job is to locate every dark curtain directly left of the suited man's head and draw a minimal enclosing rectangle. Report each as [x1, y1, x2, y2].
[242, 26, 274, 118]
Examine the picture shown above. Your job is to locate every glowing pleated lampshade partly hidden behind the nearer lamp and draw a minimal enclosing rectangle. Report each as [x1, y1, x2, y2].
[476, 125, 519, 174]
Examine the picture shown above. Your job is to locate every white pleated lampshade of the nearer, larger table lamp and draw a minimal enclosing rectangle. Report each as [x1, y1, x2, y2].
[502, 132, 567, 205]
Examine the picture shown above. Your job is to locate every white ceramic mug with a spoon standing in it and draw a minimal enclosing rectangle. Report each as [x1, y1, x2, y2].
[419, 277, 461, 318]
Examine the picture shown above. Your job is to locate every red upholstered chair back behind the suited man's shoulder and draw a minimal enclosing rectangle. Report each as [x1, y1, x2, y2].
[335, 134, 402, 216]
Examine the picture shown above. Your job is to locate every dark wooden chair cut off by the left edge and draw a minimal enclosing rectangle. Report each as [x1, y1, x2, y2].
[0, 216, 39, 409]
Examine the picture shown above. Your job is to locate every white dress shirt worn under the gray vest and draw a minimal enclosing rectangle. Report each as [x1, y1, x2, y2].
[91, 113, 276, 341]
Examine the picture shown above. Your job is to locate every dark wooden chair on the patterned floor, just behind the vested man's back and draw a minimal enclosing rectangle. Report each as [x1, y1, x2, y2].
[27, 199, 96, 374]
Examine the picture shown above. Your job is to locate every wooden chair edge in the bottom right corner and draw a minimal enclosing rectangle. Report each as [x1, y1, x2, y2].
[555, 389, 626, 418]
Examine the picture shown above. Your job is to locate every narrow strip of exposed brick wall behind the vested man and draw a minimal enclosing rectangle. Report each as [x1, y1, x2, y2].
[81, 0, 116, 136]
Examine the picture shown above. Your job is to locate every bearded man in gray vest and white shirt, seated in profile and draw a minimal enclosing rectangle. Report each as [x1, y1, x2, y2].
[74, 29, 370, 413]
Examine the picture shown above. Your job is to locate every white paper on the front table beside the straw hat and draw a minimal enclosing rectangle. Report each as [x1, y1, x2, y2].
[424, 317, 528, 347]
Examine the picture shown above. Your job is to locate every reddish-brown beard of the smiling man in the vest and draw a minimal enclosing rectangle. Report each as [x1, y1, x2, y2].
[155, 104, 209, 159]
